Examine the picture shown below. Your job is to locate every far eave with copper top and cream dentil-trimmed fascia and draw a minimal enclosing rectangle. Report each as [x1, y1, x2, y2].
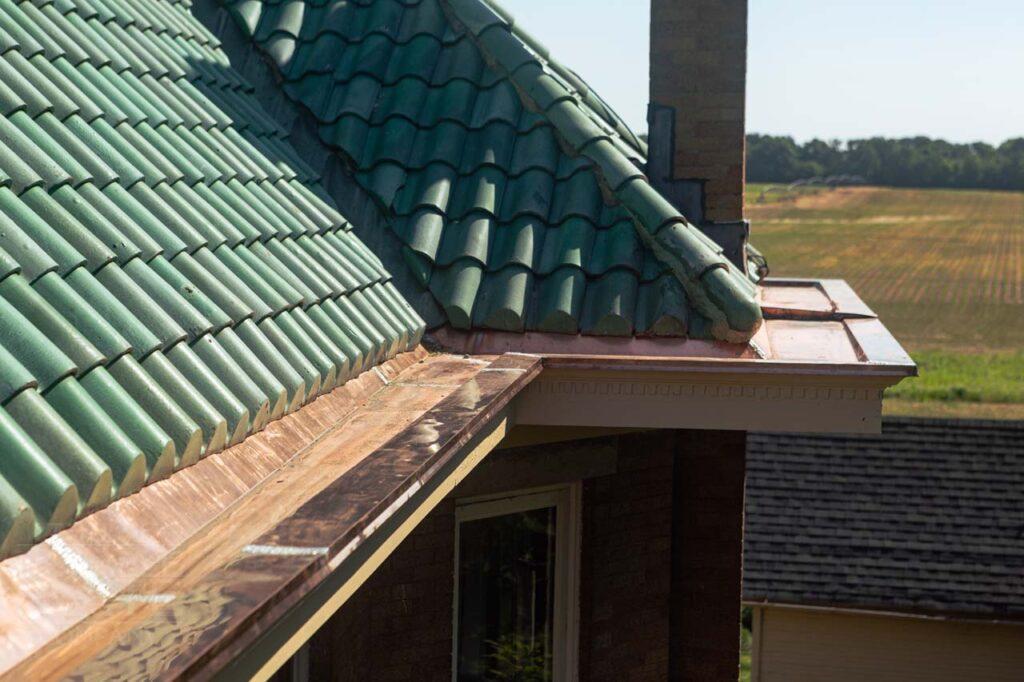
[434, 280, 916, 433]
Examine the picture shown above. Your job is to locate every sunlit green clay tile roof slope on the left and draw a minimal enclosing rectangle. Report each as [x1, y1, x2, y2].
[0, 0, 424, 558]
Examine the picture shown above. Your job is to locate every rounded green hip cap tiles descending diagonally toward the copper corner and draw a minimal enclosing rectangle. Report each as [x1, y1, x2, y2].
[441, 0, 763, 343]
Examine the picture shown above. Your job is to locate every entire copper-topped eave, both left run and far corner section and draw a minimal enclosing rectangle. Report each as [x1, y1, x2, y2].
[0, 281, 915, 679]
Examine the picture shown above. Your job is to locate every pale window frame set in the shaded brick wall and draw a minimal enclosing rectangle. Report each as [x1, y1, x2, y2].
[452, 481, 583, 682]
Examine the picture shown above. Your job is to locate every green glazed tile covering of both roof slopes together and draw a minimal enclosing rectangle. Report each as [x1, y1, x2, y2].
[0, 0, 760, 558]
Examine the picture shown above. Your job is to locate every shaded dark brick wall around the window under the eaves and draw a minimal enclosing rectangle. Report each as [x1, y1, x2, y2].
[310, 431, 744, 682]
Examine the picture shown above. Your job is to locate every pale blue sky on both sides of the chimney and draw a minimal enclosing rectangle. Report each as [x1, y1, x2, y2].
[503, 0, 1024, 142]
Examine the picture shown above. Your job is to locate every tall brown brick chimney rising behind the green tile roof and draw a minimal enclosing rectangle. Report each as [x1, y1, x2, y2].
[650, 0, 746, 222]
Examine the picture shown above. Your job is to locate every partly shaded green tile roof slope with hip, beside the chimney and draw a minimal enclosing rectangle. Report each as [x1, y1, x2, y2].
[221, 0, 761, 342]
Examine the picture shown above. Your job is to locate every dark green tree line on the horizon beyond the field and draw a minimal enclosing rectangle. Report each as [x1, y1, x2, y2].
[746, 133, 1024, 189]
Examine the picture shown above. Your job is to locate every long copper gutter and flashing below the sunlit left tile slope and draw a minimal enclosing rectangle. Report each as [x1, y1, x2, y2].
[0, 350, 540, 679]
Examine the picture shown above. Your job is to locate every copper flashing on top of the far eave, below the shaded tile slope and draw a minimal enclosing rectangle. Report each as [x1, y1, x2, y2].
[432, 280, 916, 378]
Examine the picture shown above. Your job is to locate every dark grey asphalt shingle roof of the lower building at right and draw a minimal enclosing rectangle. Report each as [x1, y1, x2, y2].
[743, 419, 1024, 620]
